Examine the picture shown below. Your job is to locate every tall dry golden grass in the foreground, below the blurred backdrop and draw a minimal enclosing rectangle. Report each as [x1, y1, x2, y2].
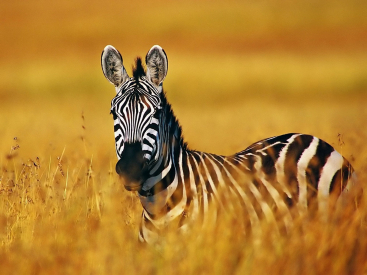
[0, 136, 367, 274]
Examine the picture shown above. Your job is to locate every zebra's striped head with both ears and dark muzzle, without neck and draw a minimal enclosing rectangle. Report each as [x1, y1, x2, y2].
[101, 45, 168, 190]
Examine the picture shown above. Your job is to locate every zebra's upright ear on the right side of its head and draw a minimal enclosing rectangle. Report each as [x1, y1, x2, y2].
[145, 45, 168, 86]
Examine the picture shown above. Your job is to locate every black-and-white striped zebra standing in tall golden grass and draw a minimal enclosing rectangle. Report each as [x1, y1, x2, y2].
[101, 45, 355, 246]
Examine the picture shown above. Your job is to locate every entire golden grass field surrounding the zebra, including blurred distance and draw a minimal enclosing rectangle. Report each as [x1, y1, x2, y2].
[0, 0, 367, 274]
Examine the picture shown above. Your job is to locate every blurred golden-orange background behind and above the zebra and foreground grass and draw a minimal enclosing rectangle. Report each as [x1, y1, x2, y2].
[0, 0, 367, 166]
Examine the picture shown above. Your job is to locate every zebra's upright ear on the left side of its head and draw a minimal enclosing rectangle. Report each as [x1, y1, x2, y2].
[101, 45, 129, 87]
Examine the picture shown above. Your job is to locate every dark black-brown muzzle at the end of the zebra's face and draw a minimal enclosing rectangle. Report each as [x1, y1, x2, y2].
[116, 142, 147, 190]
